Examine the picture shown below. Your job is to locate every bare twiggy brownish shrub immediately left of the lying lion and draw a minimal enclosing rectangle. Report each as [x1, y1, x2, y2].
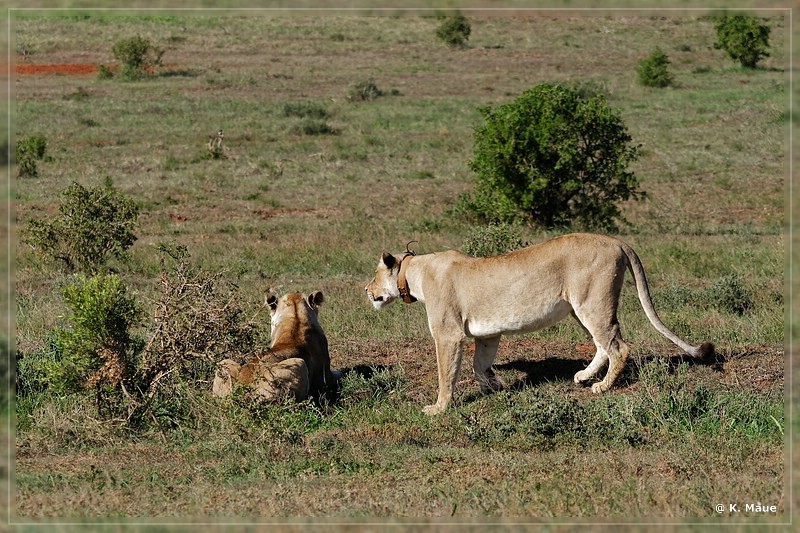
[129, 245, 258, 426]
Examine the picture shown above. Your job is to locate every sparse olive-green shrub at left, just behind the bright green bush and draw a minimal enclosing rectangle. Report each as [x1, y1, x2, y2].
[25, 178, 139, 273]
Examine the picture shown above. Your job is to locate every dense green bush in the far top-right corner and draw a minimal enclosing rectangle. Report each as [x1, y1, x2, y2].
[714, 15, 770, 68]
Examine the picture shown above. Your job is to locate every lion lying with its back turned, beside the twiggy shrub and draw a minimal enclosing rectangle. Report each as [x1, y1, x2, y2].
[212, 292, 333, 401]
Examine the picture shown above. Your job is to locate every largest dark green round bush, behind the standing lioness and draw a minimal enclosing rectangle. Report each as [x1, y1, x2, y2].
[455, 83, 643, 230]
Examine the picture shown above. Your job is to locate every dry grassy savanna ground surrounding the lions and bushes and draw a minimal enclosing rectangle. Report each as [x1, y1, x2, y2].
[12, 12, 791, 523]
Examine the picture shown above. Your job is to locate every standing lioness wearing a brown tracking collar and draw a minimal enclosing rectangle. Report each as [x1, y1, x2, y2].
[366, 233, 714, 414]
